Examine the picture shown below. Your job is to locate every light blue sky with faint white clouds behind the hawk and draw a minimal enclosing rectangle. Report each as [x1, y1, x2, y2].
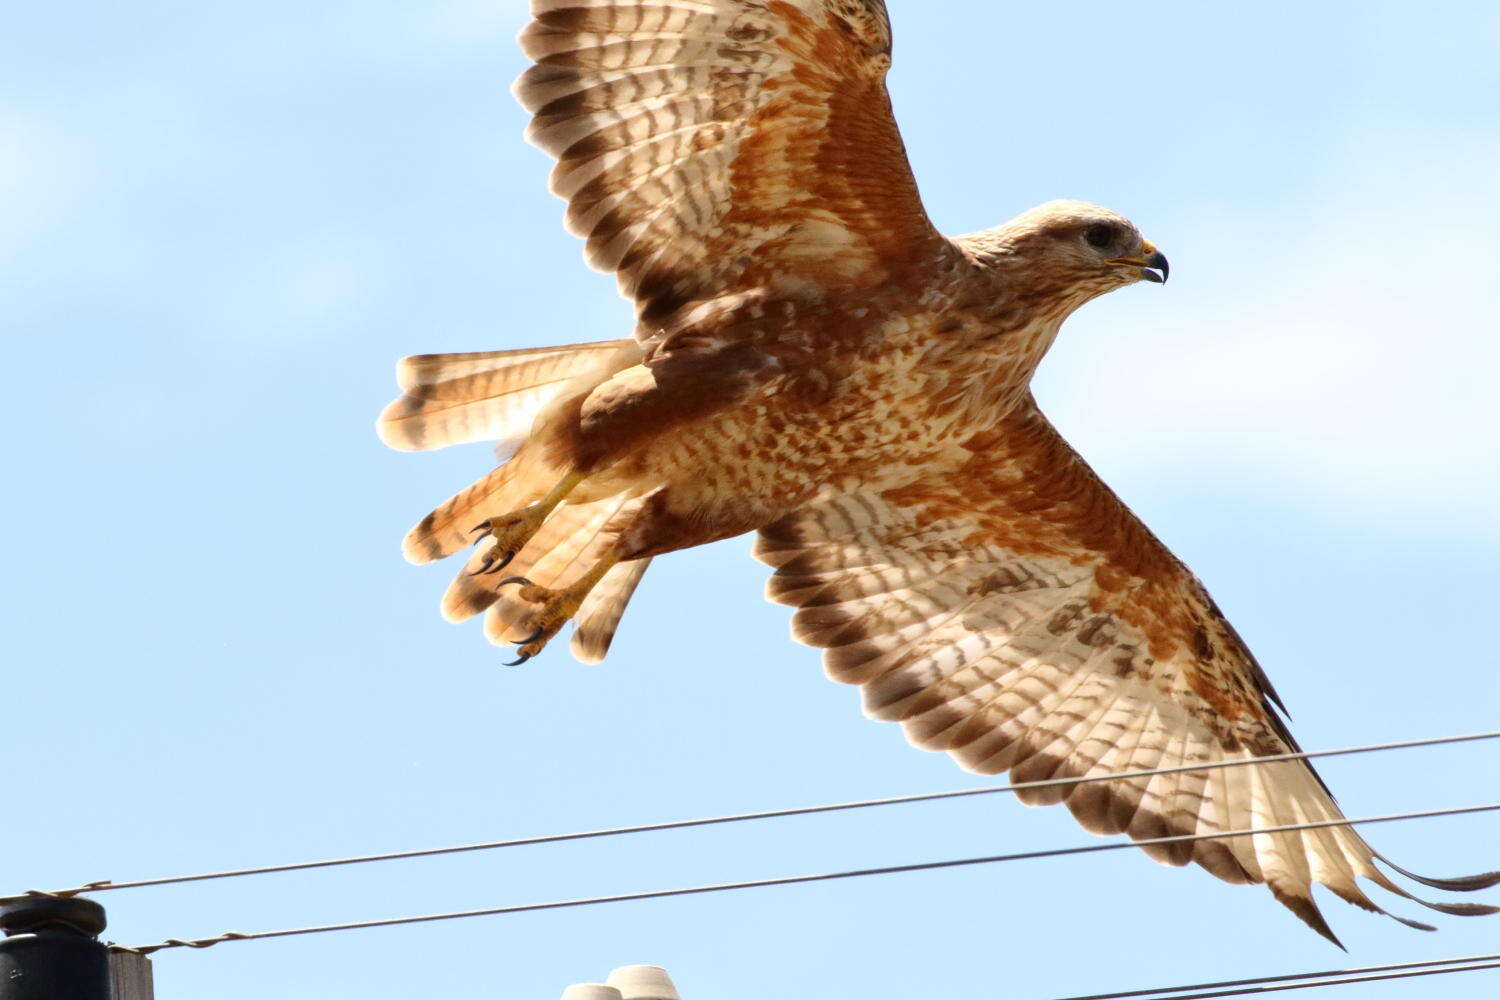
[0, 0, 1500, 1000]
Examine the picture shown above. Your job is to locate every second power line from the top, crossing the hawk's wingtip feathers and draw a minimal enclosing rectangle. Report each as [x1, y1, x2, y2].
[122, 802, 1500, 959]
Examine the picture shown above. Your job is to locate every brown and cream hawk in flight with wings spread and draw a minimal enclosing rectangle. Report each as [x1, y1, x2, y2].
[378, 0, 1500, 943]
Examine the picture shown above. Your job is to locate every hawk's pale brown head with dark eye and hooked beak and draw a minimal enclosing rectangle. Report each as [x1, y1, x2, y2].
[990, 201, 1169, 312]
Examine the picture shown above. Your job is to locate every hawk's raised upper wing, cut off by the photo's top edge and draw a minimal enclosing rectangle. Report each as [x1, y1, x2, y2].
[516, 0, 947, 329]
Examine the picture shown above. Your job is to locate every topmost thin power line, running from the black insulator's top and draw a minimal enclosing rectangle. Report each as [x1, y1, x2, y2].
[24, 730, 1500, 897]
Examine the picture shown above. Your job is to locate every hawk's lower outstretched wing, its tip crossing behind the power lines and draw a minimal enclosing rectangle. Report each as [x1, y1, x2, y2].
[756, 403, 1500, 943]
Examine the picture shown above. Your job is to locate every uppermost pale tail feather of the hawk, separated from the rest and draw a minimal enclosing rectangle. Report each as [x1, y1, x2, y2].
[375, 340, 633, 451]
